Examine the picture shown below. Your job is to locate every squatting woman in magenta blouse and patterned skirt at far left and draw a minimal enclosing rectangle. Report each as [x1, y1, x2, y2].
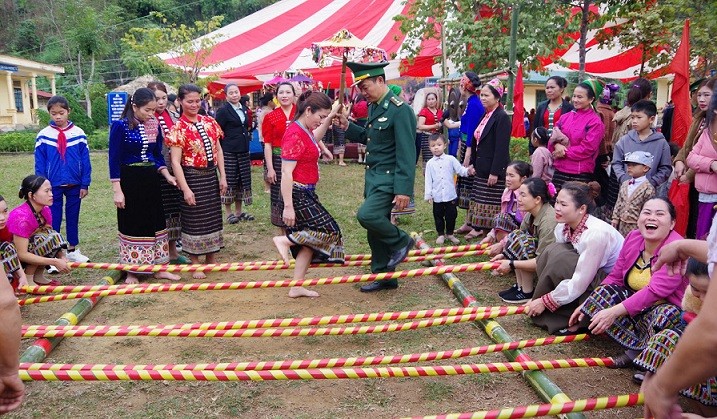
[7, 175, 70, 286]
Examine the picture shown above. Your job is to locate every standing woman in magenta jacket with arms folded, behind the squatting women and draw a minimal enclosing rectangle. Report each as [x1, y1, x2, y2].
[548, 79, 605, 191]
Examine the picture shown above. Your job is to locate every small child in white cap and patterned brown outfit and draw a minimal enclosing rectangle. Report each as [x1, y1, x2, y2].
[612, 151, 655, 237]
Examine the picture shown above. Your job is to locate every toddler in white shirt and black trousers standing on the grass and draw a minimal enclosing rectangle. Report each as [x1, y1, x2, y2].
[424, 134, 475, 244]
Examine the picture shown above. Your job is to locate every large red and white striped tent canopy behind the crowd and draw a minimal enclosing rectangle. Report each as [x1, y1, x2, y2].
[161, 0, 672, 90]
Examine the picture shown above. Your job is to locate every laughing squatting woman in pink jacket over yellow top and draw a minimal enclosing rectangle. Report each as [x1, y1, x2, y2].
[570, 198, 688, 368]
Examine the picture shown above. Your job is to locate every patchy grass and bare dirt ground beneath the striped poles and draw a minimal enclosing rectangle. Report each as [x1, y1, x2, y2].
[0, 152, 640, 418]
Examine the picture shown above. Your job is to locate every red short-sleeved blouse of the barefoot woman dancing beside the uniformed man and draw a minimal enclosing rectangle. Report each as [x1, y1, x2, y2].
[281, 121, 321, 184]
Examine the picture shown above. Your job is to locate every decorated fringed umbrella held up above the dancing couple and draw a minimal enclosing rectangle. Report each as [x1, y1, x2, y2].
[311, 29, 388, 98]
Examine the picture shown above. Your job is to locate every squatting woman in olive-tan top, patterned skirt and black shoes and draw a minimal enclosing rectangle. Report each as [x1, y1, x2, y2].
[491, 177, 557, 304]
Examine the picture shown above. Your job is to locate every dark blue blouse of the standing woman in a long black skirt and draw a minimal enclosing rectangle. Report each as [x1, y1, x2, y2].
[109, 118, 167, 182]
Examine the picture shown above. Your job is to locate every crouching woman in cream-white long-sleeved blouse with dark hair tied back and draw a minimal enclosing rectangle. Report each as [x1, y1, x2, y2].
[525, 182, 624, 335]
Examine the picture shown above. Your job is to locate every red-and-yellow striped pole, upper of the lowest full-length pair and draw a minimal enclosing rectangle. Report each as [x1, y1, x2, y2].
[20, 334, 588, 371]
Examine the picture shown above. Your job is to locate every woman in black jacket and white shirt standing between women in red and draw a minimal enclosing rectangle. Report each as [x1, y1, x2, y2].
[216, 83, 254, 224]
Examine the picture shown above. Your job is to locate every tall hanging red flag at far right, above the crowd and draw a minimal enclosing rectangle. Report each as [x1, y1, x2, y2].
[670, 19, 692, 146]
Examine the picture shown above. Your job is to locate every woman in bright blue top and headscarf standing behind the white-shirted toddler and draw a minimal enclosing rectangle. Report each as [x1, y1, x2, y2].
[455, 71, 486, 240]
